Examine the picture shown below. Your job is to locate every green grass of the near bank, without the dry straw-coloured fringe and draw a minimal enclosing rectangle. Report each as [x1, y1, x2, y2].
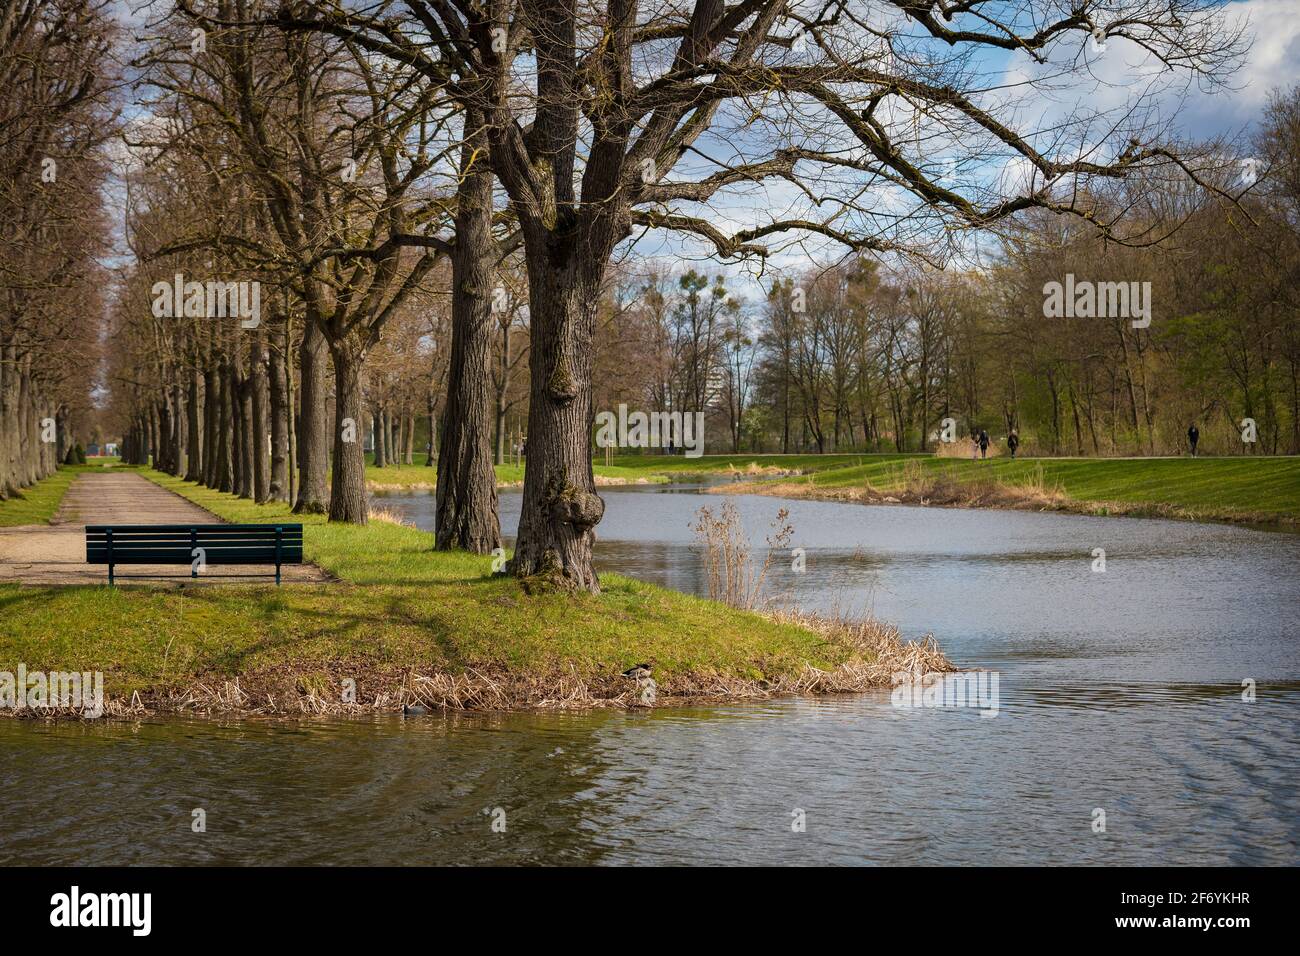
[0, 471, 846, 693]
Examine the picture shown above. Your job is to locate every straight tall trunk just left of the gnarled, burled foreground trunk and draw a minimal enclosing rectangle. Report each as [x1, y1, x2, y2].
[434, 127, 499, 554]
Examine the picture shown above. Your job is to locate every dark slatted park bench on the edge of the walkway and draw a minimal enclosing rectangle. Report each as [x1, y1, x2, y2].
[86, 524, 303, 584]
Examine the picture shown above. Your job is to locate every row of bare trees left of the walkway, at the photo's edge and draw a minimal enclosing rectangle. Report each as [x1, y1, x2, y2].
[0, 0, 113, 499]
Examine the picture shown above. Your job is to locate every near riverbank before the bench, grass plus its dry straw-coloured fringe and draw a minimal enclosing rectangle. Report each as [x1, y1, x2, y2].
[0, 471, 952, 715]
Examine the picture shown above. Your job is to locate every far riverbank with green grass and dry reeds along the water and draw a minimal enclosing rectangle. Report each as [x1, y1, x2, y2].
[608, 455, 1300, 529]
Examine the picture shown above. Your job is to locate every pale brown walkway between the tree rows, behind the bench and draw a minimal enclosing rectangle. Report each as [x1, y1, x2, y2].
[0, 472, 328, 587]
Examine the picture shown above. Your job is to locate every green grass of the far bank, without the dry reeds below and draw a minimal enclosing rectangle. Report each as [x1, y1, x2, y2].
[733, 458, 1300, 520]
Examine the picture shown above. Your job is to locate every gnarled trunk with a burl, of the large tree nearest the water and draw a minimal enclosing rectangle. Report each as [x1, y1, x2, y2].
[510, 251, 605, 592]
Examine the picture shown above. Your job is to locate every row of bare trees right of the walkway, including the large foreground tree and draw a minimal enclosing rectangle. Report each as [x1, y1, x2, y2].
[83, 0, 1240, 591]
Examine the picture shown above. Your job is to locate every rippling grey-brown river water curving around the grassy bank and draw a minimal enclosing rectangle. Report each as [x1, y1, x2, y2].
[0, 485, 1300, 865]
